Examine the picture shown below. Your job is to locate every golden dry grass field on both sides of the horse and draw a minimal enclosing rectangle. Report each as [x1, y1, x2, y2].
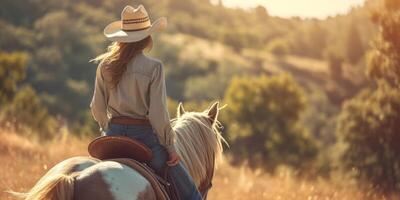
[0, 131, 394, 200]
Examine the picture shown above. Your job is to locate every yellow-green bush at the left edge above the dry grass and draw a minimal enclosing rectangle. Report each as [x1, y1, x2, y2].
[0, 52, 57, 138]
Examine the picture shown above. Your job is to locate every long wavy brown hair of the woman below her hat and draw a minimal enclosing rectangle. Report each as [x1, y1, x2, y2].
[91, 36, 153, 88]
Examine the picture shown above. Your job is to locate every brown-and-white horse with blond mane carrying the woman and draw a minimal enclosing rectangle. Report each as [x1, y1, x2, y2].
[13, 102, 227, 200]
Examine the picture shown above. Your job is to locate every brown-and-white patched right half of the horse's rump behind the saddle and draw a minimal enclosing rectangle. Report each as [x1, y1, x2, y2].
[74, 161, 156, 200]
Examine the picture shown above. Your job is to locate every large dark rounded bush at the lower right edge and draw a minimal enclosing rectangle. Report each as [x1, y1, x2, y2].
[337, 83, 400, 191]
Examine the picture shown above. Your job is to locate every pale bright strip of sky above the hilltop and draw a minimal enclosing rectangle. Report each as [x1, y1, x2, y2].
[214, 0, 364, 19]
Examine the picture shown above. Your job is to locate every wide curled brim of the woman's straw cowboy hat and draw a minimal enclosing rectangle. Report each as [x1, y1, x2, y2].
[104, 17, 167, 42]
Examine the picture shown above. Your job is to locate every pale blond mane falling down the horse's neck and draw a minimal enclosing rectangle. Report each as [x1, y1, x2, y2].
[172, 112, 226, 186]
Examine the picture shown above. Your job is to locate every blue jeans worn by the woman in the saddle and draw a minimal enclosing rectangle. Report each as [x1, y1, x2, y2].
[106, 124, 202, 200]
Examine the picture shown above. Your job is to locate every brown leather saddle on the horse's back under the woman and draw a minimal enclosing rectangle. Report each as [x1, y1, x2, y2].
[88, 136, 180, 200]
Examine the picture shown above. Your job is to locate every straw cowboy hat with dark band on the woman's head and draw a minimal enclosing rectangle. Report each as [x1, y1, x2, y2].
[104, 5, 167, 42]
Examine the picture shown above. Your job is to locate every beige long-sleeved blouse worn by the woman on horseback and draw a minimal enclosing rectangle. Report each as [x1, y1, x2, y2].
[90, 53, 175, 151]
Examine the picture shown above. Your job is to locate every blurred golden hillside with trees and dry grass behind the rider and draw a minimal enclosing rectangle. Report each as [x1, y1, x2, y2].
[0, 0, 400, 199]
